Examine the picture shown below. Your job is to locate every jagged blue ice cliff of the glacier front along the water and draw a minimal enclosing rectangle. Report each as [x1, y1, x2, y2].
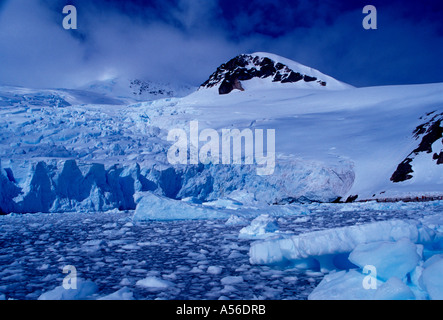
[0, 158, 354, 214]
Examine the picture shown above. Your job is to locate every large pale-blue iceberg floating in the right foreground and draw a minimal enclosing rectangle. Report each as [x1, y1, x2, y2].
[249, 215, 443, 300]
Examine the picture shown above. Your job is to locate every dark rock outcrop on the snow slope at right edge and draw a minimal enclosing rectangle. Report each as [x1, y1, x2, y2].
[391, 112, 443, 182]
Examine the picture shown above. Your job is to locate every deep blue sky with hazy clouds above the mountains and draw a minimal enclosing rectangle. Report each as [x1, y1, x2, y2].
[0, 0, 443, 88]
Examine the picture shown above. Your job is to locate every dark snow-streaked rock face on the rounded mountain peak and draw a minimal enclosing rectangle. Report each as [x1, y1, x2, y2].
[201, 54, 327, 94]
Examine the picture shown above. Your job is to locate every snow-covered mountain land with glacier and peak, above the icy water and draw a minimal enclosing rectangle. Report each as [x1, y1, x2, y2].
[0, 53, 443, 213]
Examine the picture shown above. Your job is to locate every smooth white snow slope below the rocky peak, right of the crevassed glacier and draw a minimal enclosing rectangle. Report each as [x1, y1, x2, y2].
[171, 79, 443, 200]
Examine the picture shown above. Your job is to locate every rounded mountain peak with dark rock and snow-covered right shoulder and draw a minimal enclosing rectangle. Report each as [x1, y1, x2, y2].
[200, 52, 351, 95]
